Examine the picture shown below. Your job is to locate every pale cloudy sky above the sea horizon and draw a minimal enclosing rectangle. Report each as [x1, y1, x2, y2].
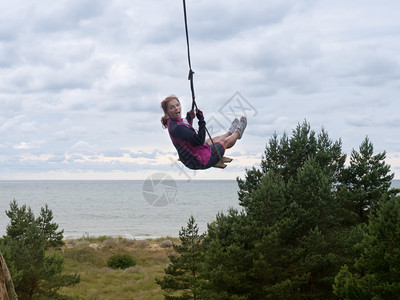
[0, 0, 400, 180]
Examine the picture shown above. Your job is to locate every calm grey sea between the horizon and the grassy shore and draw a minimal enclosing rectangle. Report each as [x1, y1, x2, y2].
[0, 179, 400, 239]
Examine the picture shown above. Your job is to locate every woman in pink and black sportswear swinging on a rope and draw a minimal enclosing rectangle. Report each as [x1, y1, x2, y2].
[161, 95, 247, 170]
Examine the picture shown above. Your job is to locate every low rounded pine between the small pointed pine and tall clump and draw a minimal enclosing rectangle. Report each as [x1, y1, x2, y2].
[201, 209, 257, 300]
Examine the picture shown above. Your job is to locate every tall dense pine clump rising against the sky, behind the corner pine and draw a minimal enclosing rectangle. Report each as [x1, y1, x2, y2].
[161, 122, 400, 299]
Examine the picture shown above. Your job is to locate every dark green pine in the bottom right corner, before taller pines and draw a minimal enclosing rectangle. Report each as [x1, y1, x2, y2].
[333, 195, 400, 299]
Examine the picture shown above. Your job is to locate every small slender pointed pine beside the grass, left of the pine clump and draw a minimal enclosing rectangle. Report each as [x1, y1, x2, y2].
[156, 216, 204, 300]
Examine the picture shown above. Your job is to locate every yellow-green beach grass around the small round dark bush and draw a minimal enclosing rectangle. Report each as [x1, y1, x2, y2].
[53, 236, 179, 300]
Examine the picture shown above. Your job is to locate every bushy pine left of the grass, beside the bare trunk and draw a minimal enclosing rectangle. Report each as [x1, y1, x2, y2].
[0, 200, 79, 299]
